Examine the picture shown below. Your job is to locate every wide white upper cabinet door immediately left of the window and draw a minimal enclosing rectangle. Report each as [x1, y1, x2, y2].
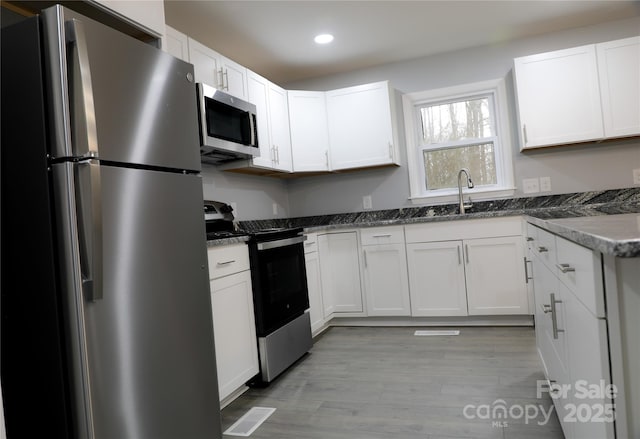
[327, 81, 397, 170]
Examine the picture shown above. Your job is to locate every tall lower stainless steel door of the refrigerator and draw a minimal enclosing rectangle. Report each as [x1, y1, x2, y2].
[72, 165, 221, 439]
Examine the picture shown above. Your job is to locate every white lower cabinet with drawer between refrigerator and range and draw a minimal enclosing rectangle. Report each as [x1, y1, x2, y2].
[208, 244, 259, 401]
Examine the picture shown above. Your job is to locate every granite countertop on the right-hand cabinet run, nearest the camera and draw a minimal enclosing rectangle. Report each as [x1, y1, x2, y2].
[527, 213, 640, 258]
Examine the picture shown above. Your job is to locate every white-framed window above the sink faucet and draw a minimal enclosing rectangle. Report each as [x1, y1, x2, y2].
[403, 80, 514, 203]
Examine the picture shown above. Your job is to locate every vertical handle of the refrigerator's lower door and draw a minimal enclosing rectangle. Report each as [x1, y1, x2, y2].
[75, 160, 103, 301]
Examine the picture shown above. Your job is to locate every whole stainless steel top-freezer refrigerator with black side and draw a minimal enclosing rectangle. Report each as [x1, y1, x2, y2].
[0, 6, 222, 439]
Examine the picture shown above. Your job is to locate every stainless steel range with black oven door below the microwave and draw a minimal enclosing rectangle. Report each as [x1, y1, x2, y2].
[205, 201, 313, 385]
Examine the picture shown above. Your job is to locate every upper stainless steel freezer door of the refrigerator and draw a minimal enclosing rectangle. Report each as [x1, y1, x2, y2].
[43, 6, 201, 171]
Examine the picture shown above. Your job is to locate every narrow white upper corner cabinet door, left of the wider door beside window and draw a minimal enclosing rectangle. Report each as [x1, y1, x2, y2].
[288, 90, 329, 172]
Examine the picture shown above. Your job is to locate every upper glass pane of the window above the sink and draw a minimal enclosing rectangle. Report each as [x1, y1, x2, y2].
[420, 97, 494, 144]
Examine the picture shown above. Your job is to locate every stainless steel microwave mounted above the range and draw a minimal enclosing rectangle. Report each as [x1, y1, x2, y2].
[196, 83, 260, 164]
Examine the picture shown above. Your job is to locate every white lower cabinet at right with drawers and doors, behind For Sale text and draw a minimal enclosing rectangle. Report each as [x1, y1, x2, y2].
[529, 226, 616, 439]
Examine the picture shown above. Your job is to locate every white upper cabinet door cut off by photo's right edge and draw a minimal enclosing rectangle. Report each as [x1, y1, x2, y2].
[596, 37, 640, 137]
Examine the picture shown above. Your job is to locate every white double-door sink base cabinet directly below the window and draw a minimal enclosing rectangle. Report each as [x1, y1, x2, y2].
[405, 217, 530, 316]
